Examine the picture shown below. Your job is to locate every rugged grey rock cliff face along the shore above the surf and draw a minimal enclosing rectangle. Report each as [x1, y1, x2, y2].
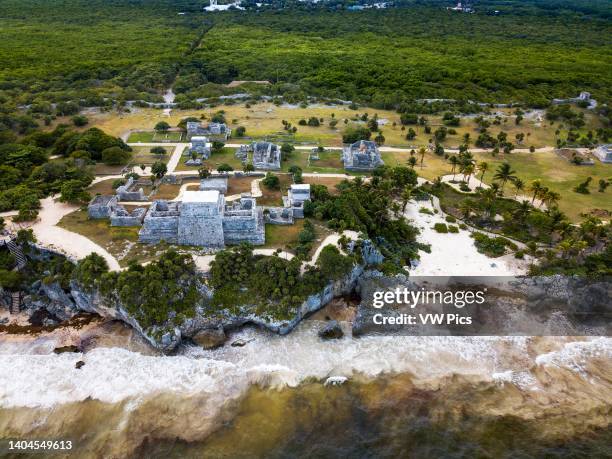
[0, 246, 612, 353]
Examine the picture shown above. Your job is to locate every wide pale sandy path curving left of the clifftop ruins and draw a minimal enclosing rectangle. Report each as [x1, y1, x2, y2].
[32, 197, 120, 271]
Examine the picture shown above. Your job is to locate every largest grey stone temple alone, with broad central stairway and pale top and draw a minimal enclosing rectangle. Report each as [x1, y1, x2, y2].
[139, 190, 265, 248]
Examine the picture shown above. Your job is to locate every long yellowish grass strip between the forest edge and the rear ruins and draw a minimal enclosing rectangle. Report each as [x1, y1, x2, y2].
[90, 102, 601, 148]
